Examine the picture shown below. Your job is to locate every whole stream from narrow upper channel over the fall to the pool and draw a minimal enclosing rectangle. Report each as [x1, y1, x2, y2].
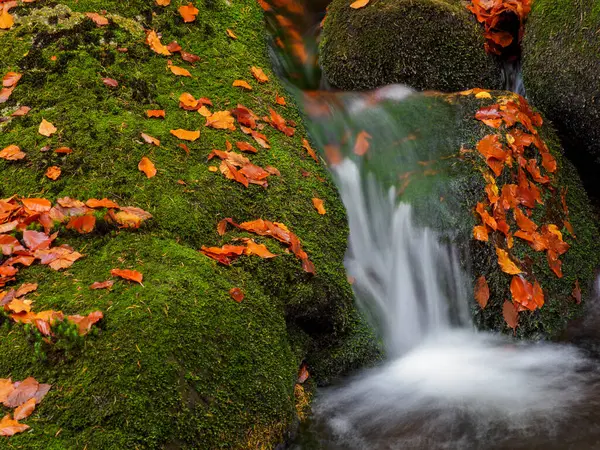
[267, 1, 600, 450]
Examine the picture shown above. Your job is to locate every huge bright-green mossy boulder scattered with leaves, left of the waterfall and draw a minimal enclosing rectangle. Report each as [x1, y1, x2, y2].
[0, 0, 379, 450]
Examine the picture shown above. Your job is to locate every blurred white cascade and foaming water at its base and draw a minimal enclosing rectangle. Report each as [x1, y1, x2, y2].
[302, 159, 600, 450]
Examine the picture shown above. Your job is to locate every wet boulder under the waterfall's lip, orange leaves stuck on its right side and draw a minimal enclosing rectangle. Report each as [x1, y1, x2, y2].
[307, 86, 600, 339]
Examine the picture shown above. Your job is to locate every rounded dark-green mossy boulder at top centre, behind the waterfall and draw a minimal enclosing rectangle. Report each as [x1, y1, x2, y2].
[321, 0, 502, 92]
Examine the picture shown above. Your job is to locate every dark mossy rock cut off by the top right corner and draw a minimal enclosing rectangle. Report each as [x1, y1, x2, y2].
[523, 0, 600, 197]
